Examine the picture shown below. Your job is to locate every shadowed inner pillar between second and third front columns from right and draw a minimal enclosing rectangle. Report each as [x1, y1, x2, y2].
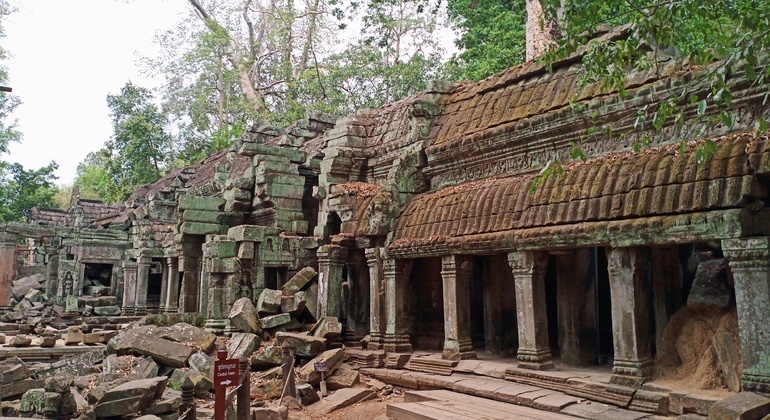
[556, 248, 596, 366]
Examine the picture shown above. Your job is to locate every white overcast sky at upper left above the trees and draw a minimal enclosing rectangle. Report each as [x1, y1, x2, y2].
[0, 0, 189, 184]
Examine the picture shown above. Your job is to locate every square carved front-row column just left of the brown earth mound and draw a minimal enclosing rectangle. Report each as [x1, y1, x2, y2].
[607, 247, 653, 387]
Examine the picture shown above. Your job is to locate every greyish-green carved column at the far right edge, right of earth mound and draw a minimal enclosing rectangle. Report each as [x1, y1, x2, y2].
[722, 237, 770, 393]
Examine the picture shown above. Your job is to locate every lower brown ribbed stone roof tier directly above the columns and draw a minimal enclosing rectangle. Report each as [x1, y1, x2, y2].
[390, 132, 770, 254]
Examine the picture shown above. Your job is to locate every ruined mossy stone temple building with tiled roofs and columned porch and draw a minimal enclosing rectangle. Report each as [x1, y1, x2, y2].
[0, 26, 770, 398]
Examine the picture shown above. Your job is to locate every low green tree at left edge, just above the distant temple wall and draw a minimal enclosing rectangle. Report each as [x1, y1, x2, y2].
[0, 162, 58, 222]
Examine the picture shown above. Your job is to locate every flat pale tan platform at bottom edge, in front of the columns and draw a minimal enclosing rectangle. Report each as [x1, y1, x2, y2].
[387, 391, 575, 420]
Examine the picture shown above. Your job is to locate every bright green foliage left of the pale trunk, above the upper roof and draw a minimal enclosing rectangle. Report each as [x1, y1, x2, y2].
[447, 0, 526, 81]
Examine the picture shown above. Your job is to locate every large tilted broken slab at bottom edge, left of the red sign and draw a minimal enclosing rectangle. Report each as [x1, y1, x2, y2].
[94, 377, 168, 417]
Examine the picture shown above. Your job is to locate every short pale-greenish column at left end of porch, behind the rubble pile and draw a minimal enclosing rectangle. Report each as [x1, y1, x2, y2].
[317, 245, 348, 319]
